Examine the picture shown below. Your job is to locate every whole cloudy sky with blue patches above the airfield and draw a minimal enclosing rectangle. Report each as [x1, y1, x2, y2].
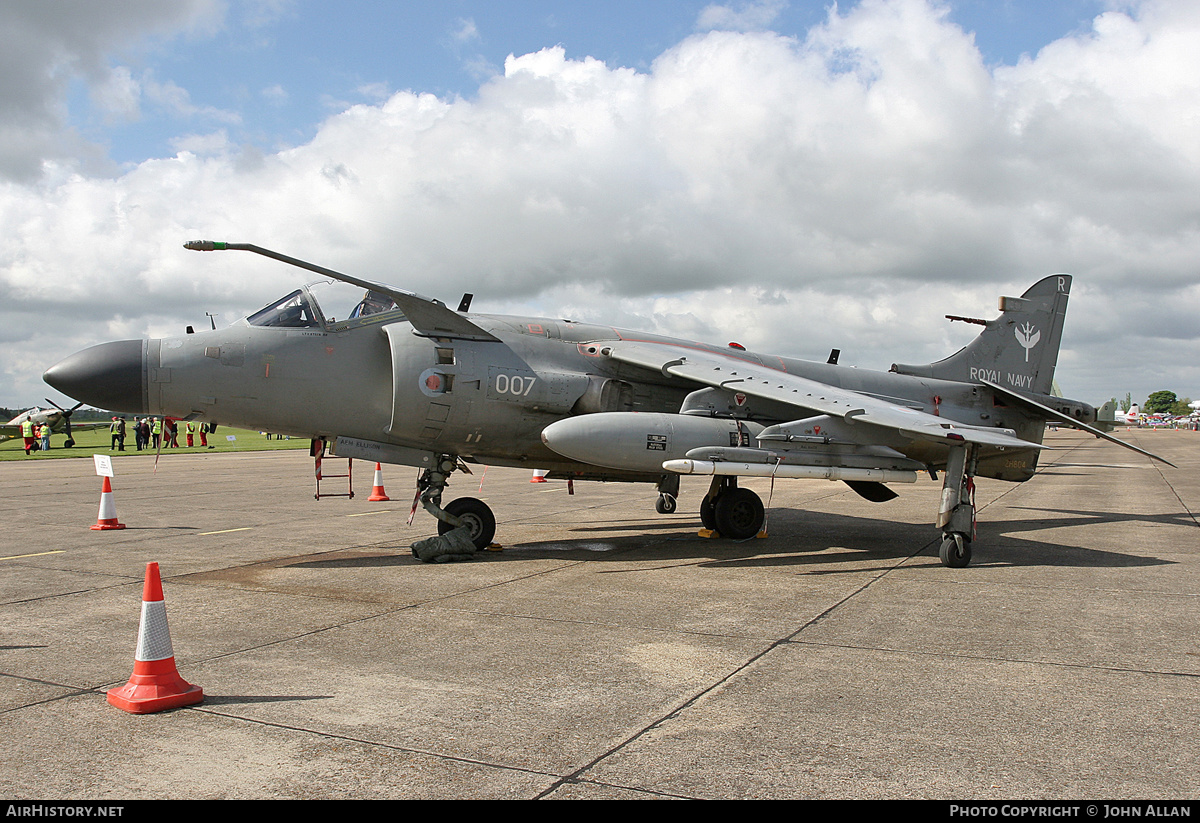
[0, 0, 1200, 407]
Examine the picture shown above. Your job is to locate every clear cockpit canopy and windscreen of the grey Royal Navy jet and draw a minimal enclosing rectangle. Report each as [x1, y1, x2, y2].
[246, 281, 404, 331]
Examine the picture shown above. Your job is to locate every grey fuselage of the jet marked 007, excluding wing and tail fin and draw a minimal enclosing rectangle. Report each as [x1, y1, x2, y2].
[47, 301, 1065, 480]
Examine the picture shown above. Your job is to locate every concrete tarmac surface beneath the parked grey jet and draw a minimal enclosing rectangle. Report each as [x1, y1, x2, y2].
[0, 431, 1200, 800]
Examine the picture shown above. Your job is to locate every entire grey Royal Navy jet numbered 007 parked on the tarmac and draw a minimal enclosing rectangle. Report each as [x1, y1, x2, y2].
[44, 241, 1165, 567]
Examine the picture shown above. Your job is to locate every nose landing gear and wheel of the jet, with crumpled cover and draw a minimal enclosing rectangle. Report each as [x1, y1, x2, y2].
[413, 455, 496, 561]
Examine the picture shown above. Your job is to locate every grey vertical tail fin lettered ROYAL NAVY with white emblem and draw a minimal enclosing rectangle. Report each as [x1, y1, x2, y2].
[892, 275, 1070, 395]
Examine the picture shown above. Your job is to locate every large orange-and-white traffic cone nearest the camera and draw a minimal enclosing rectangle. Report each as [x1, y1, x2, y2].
[108, 563, 204, 714]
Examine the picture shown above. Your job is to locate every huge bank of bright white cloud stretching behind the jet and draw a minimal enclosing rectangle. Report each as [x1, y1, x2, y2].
[0, 0, 1200, 406]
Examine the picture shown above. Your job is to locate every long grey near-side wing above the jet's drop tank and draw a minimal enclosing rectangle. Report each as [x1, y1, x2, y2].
[602, 342, 1045, 458]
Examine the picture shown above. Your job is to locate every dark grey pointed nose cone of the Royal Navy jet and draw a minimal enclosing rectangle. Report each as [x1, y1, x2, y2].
[42, 340, 149, 414]
